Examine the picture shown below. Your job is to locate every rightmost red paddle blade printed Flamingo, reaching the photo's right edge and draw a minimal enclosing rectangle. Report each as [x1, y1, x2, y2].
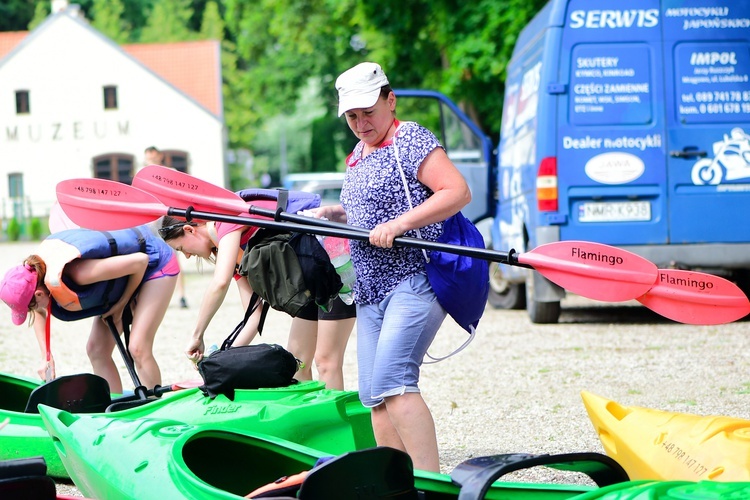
[638, 269, 750, 325]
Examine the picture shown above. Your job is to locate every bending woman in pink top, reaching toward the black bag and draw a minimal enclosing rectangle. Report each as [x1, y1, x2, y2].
[159, 216, 356, 389]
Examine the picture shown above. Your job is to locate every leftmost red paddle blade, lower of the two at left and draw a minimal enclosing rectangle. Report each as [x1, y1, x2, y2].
[57, 179, 167, 231]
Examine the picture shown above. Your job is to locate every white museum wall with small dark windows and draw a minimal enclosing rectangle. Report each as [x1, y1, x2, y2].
[0, 12, 226, 217]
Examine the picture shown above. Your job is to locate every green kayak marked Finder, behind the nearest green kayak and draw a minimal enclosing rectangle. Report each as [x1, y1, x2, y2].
[0, 373, 374, 478]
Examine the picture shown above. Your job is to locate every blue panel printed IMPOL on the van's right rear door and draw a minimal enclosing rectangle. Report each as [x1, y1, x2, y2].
[674, 42, 750, 123]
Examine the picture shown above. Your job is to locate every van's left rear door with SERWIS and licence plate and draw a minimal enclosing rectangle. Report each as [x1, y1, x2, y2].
[560, 0, 669, 245]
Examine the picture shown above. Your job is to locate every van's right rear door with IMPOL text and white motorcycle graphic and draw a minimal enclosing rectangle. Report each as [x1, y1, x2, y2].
[662, 0, 750, 244]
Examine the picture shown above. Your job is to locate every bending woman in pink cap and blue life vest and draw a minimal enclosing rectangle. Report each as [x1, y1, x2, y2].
[0, 226, 179, 393]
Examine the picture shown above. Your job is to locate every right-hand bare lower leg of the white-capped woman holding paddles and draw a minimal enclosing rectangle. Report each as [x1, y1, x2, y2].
[388, 392, 440, 472]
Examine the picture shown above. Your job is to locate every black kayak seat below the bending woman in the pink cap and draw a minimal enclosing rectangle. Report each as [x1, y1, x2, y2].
[24, 373, 112, 413]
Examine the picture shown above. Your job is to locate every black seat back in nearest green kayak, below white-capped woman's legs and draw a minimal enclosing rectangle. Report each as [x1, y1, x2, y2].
[298, 446, 419, 500]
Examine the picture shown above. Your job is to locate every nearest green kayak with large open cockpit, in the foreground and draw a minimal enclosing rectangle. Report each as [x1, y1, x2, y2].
[40, 407, 594, 500]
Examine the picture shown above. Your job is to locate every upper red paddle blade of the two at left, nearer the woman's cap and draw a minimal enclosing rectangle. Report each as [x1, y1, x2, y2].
[133, 165, 248, 215]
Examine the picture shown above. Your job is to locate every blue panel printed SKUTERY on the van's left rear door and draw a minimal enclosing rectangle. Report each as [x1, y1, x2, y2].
[569, 43, 653, 125]
